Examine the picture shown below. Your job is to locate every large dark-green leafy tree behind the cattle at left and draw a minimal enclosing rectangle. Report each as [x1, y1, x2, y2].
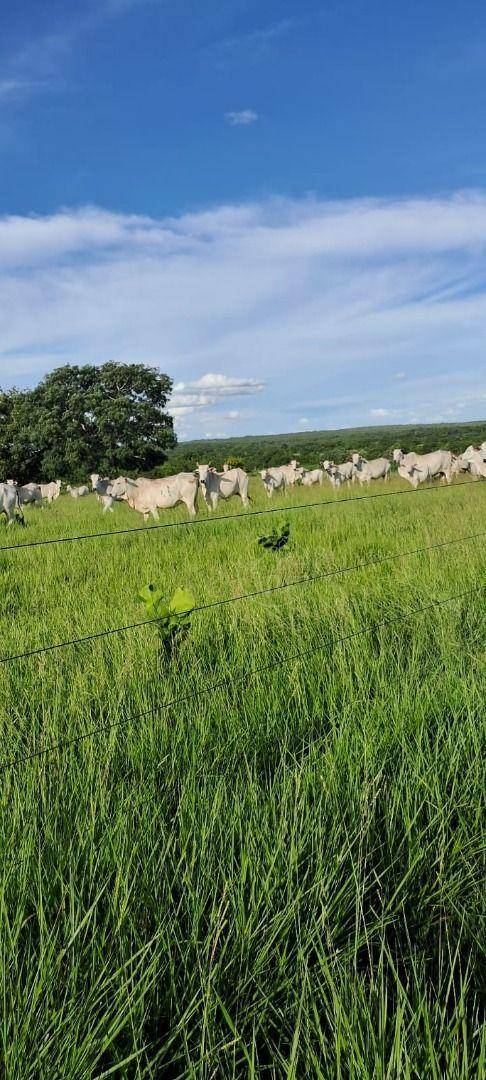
[0, 363, 176, 481]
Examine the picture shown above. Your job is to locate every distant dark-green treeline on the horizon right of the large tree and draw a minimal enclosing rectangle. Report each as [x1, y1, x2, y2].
[153, 420, 486, 476]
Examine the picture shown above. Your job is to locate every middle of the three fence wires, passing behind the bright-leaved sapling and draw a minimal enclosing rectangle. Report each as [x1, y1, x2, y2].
[0, 529, 486, 664]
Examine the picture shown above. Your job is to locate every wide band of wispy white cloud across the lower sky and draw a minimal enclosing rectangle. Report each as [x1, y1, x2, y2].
[0, 192, 486, 434]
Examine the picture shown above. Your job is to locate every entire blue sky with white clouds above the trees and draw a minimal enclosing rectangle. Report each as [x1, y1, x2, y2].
[0, 0, 486, 437]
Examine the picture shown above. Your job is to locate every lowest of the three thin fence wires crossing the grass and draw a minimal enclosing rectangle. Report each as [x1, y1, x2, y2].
[0, 584, 486, 772]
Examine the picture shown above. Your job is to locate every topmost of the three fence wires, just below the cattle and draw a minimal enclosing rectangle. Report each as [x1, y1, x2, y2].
[0, 480, 478, 552]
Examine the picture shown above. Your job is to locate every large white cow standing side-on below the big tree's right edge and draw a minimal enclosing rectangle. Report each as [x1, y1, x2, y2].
[111, 473, 199, 522]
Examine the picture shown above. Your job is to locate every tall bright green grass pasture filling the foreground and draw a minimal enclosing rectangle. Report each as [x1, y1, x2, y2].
[0, 476, 486, 1080]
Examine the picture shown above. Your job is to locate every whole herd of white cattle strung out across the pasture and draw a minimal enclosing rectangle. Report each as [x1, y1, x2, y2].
[0, 442, 486, 525]
